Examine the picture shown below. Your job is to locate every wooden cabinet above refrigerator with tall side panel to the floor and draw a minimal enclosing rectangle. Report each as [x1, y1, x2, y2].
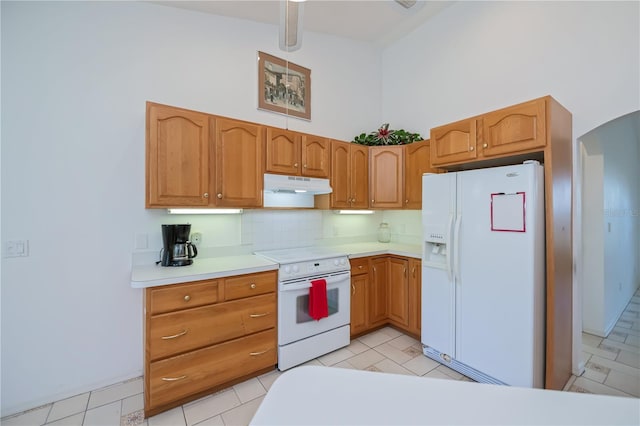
[431, 96, 573, 389]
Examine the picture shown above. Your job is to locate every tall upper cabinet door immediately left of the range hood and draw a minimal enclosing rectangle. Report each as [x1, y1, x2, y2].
[212, 117, 264, 207]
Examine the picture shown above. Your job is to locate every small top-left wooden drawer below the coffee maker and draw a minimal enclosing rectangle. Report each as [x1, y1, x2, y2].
[147, 280, 218, 315]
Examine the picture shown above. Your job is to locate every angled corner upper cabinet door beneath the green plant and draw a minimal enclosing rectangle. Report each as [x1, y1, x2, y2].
[369, 146, 404, 208]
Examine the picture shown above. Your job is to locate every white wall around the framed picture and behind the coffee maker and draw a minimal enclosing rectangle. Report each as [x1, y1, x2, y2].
[1, 1, 381, 415]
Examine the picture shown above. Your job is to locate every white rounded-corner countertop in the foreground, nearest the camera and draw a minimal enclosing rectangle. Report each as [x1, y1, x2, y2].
[250, 366, 640, 426]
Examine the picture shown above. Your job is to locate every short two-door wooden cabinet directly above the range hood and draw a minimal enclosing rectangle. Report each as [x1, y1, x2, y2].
[265, 127, 331, 179]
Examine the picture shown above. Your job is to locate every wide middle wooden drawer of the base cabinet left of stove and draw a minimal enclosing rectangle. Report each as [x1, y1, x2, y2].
[149, 294, 277, 361]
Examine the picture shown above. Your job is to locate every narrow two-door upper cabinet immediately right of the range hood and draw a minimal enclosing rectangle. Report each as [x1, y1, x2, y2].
[329, 140, 369, 209]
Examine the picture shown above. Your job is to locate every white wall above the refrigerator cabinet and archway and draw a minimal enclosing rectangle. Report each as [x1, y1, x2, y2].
[382, 1, 640, 374]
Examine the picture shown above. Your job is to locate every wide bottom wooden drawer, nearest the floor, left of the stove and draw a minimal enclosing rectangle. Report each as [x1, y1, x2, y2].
[148, 330, 277, 408]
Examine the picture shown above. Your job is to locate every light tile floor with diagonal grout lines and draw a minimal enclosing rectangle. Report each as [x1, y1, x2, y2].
[5, 290, 640, 426]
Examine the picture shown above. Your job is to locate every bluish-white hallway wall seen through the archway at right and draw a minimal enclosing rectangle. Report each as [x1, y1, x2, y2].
[580, 112, 640, 337]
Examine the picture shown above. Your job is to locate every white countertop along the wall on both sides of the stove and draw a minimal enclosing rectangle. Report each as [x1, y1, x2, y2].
[131, 242, 422, 288]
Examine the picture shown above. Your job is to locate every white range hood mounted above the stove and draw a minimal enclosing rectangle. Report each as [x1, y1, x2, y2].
[264, 173, 333, 208]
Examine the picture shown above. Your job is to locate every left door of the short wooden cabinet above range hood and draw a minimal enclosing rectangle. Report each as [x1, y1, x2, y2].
[265, 127, 302, 175]
